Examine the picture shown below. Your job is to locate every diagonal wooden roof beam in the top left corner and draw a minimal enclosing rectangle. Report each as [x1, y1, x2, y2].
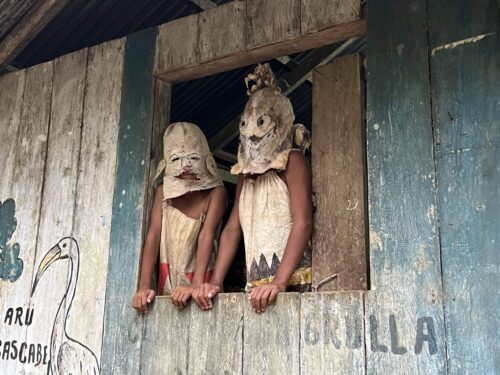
[0, 0, 69, 68]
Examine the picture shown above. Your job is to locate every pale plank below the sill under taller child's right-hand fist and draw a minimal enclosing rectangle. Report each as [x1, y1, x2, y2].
[243, 293, 300, 375]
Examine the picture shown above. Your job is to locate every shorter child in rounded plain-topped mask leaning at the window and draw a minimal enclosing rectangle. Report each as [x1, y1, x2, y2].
[132, 122, 226, 313]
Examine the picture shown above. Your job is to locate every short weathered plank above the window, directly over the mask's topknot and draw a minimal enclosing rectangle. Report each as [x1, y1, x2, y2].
[245, 0, 300, 49]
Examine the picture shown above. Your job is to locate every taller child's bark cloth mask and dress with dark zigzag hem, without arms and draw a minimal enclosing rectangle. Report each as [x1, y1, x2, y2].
[231, 64, 312, 291]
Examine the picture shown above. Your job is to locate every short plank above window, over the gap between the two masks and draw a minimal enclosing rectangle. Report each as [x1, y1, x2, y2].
[198, 0, 245, 62]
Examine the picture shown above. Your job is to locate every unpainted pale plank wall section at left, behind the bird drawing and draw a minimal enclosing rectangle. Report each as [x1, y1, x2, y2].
[0, 39, 124, 374]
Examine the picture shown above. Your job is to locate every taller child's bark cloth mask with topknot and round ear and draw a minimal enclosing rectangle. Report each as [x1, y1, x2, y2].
[231, 64, 311, 174]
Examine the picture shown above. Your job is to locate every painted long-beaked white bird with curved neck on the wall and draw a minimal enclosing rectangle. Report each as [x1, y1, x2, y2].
[31, 237, 99, 375]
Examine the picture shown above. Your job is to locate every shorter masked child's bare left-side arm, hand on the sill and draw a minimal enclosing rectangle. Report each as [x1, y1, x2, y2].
[132, 185, 163, 313]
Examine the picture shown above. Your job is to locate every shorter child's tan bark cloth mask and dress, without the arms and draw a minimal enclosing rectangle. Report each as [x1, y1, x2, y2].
[155, 122, 222, 294]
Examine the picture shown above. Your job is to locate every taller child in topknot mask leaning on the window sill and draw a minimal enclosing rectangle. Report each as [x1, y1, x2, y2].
[193, 64, 312, 313]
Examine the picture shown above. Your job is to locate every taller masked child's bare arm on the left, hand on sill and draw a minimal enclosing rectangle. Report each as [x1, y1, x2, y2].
[193, 176, 243, 310]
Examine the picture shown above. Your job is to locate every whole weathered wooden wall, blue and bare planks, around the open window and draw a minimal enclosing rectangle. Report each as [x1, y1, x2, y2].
[0, 0, 500, 374]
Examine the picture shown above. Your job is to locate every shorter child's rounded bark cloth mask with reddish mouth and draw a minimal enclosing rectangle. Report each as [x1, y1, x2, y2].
[155, 122, 222, 199]
